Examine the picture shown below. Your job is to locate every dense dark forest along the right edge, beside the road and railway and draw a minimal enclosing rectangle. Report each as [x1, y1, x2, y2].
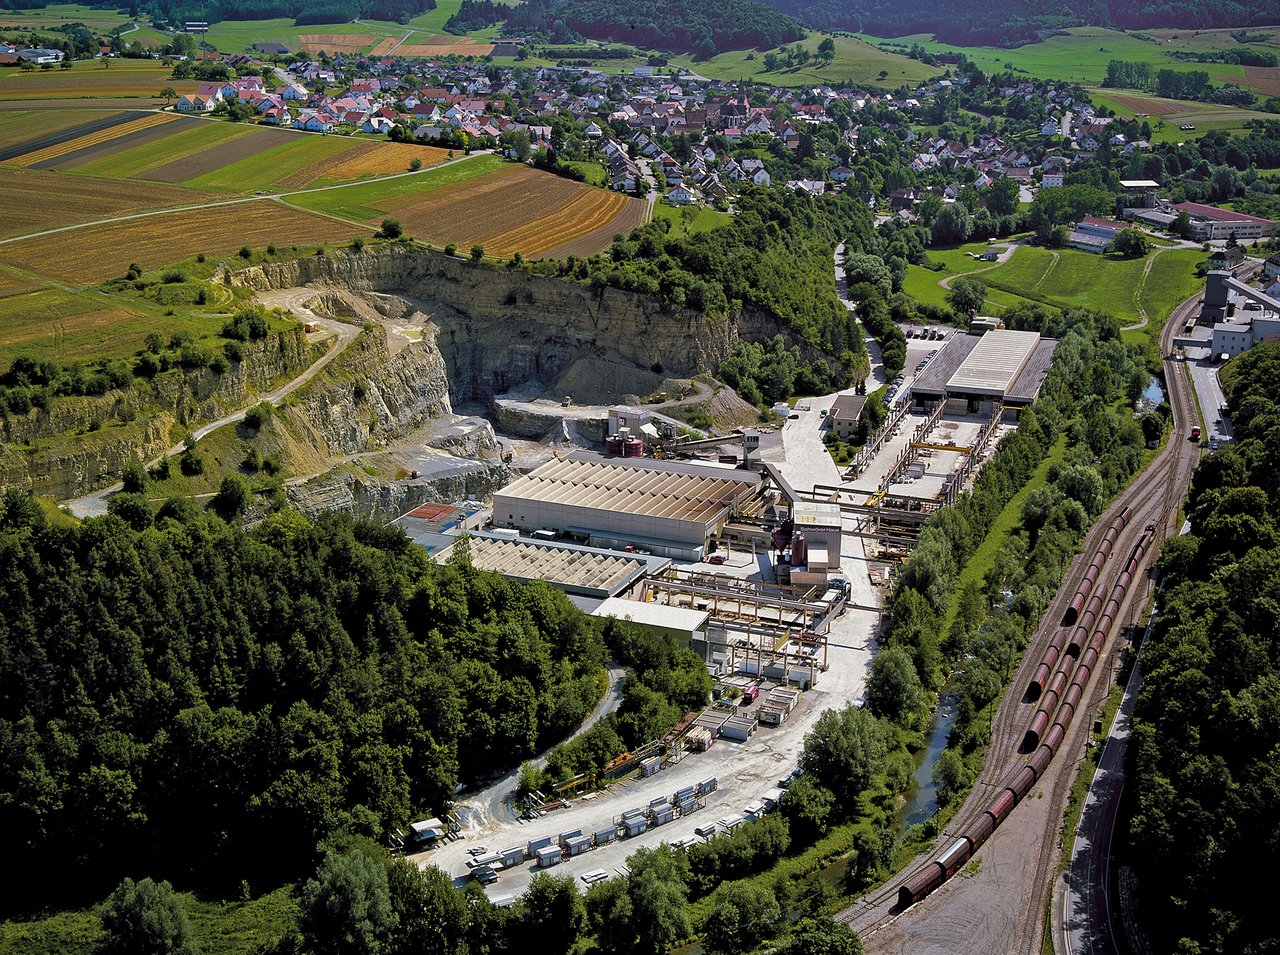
[1130, 344, 1280, 955]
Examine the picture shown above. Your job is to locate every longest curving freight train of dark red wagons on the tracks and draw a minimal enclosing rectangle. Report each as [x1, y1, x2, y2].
[897, 517, 1155, 909]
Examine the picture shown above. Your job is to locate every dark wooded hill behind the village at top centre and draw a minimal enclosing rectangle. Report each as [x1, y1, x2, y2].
[507, 0, 804, 56]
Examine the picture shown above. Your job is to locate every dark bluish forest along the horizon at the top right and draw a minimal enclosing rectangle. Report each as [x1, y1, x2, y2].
[747, 0, 1275, 46]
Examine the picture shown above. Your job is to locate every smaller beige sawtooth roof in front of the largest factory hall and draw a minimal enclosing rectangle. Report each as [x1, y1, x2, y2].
[455, 538, 645, 595]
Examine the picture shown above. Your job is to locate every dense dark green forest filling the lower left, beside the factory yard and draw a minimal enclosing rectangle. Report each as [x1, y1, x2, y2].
[0, 492, 709, 906]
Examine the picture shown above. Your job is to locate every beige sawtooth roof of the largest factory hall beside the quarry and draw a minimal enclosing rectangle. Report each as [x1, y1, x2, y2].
[494, 457, 760, 522]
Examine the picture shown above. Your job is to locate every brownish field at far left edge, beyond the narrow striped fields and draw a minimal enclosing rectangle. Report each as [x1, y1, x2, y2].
[0, 59, 197, 102]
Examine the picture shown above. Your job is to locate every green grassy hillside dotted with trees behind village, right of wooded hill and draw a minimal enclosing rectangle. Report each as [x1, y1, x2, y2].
[671, 33, 942, 87]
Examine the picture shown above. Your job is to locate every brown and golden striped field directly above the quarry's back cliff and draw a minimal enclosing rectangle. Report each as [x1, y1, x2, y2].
[289, 156, 644, 257]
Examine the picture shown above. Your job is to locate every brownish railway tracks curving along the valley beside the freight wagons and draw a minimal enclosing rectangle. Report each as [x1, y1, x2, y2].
[837, 296, 1199, 955]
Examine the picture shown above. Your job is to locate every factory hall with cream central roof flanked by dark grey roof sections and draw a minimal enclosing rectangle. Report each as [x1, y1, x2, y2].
[911, 329, 1057, 415]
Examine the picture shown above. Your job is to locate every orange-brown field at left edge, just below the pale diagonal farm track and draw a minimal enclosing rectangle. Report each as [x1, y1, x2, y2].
[0, 200, 370, 285]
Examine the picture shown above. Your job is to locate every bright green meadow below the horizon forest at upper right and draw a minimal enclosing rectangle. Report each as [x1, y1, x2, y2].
[868, 27, 1260, 86]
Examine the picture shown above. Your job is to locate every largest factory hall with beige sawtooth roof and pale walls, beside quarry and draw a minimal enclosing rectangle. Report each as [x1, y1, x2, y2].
[493, 452, 762, 561]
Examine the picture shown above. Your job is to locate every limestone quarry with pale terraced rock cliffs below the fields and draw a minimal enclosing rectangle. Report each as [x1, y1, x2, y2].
[35, 246, 824, 518]
